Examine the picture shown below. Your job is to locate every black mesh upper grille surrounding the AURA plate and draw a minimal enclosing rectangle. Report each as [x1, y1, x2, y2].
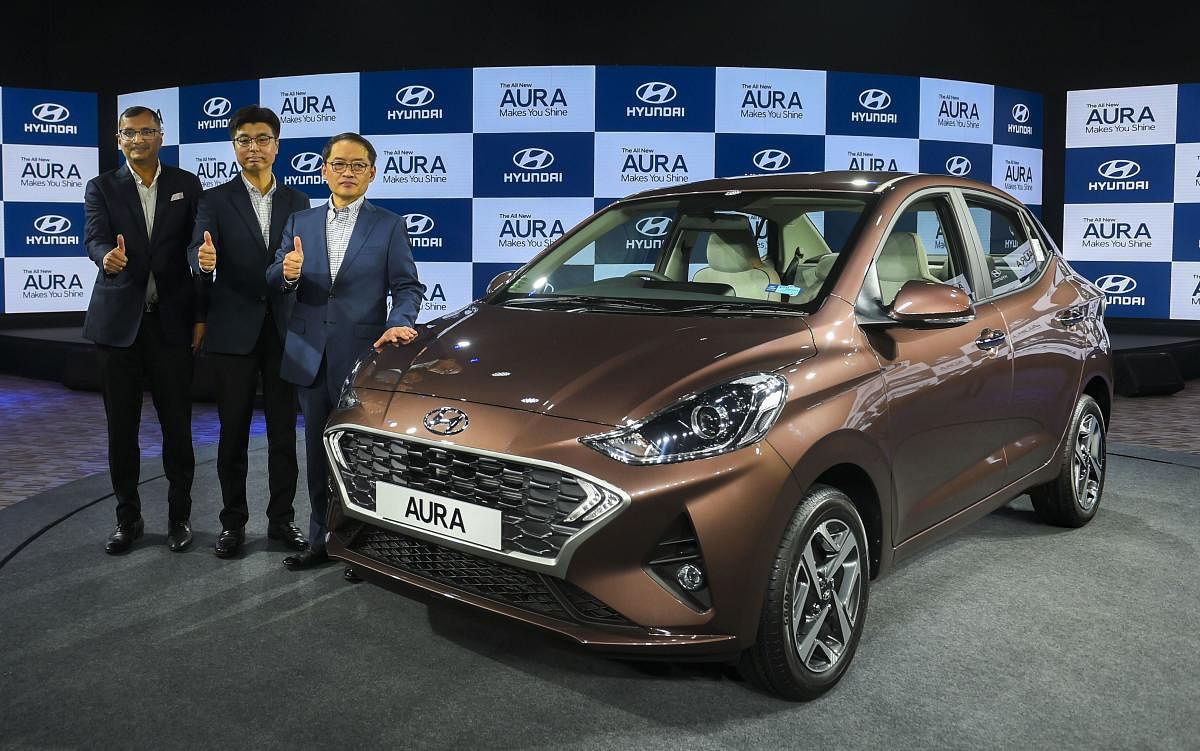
[337, 431, 604, 558]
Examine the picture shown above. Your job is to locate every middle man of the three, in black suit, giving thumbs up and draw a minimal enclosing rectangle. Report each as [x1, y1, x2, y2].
[187, 106, 308, 558]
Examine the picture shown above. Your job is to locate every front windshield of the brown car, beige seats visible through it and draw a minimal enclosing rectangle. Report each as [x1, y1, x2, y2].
[491, 191, 866, 316]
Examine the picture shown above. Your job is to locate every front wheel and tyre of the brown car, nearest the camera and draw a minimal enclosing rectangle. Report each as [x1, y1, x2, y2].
[742, 485, 870, 701]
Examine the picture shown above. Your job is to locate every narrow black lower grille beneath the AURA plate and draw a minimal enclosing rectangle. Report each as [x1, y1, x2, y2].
[348, 524, 632, 626]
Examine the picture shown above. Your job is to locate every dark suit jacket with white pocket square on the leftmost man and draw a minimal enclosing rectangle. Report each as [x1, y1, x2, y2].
[83, 164, 203, 347]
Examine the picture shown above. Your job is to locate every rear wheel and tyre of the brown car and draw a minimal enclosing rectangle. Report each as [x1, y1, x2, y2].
[1030, 393, 1108, 527]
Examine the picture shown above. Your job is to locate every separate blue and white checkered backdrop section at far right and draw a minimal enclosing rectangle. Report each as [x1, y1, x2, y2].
[1062, 84, 1200, 320]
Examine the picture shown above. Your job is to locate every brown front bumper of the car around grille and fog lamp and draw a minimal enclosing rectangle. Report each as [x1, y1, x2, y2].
[326, 392, 799, 656]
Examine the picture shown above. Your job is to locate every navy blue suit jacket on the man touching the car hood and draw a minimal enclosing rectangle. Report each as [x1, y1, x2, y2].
[267, 202, 425, 386]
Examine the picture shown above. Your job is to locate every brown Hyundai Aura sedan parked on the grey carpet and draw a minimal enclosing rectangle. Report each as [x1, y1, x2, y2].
[325, 173, 1112, 698]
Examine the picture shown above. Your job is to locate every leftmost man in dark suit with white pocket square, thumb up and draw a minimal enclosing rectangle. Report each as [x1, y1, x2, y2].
[83, 107, 204, 554]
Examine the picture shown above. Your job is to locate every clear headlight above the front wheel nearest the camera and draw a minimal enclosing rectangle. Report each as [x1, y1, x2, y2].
[580, 373, 787, 464]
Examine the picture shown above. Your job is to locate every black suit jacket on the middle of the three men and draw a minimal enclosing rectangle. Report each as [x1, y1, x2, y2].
[187, 175, 308, 355]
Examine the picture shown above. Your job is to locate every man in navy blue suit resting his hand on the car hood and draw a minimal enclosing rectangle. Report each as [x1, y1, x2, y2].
[266, 133, 425, 569]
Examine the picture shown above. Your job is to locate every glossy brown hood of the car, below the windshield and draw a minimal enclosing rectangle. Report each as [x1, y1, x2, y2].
[354, 304, 816, 426]
